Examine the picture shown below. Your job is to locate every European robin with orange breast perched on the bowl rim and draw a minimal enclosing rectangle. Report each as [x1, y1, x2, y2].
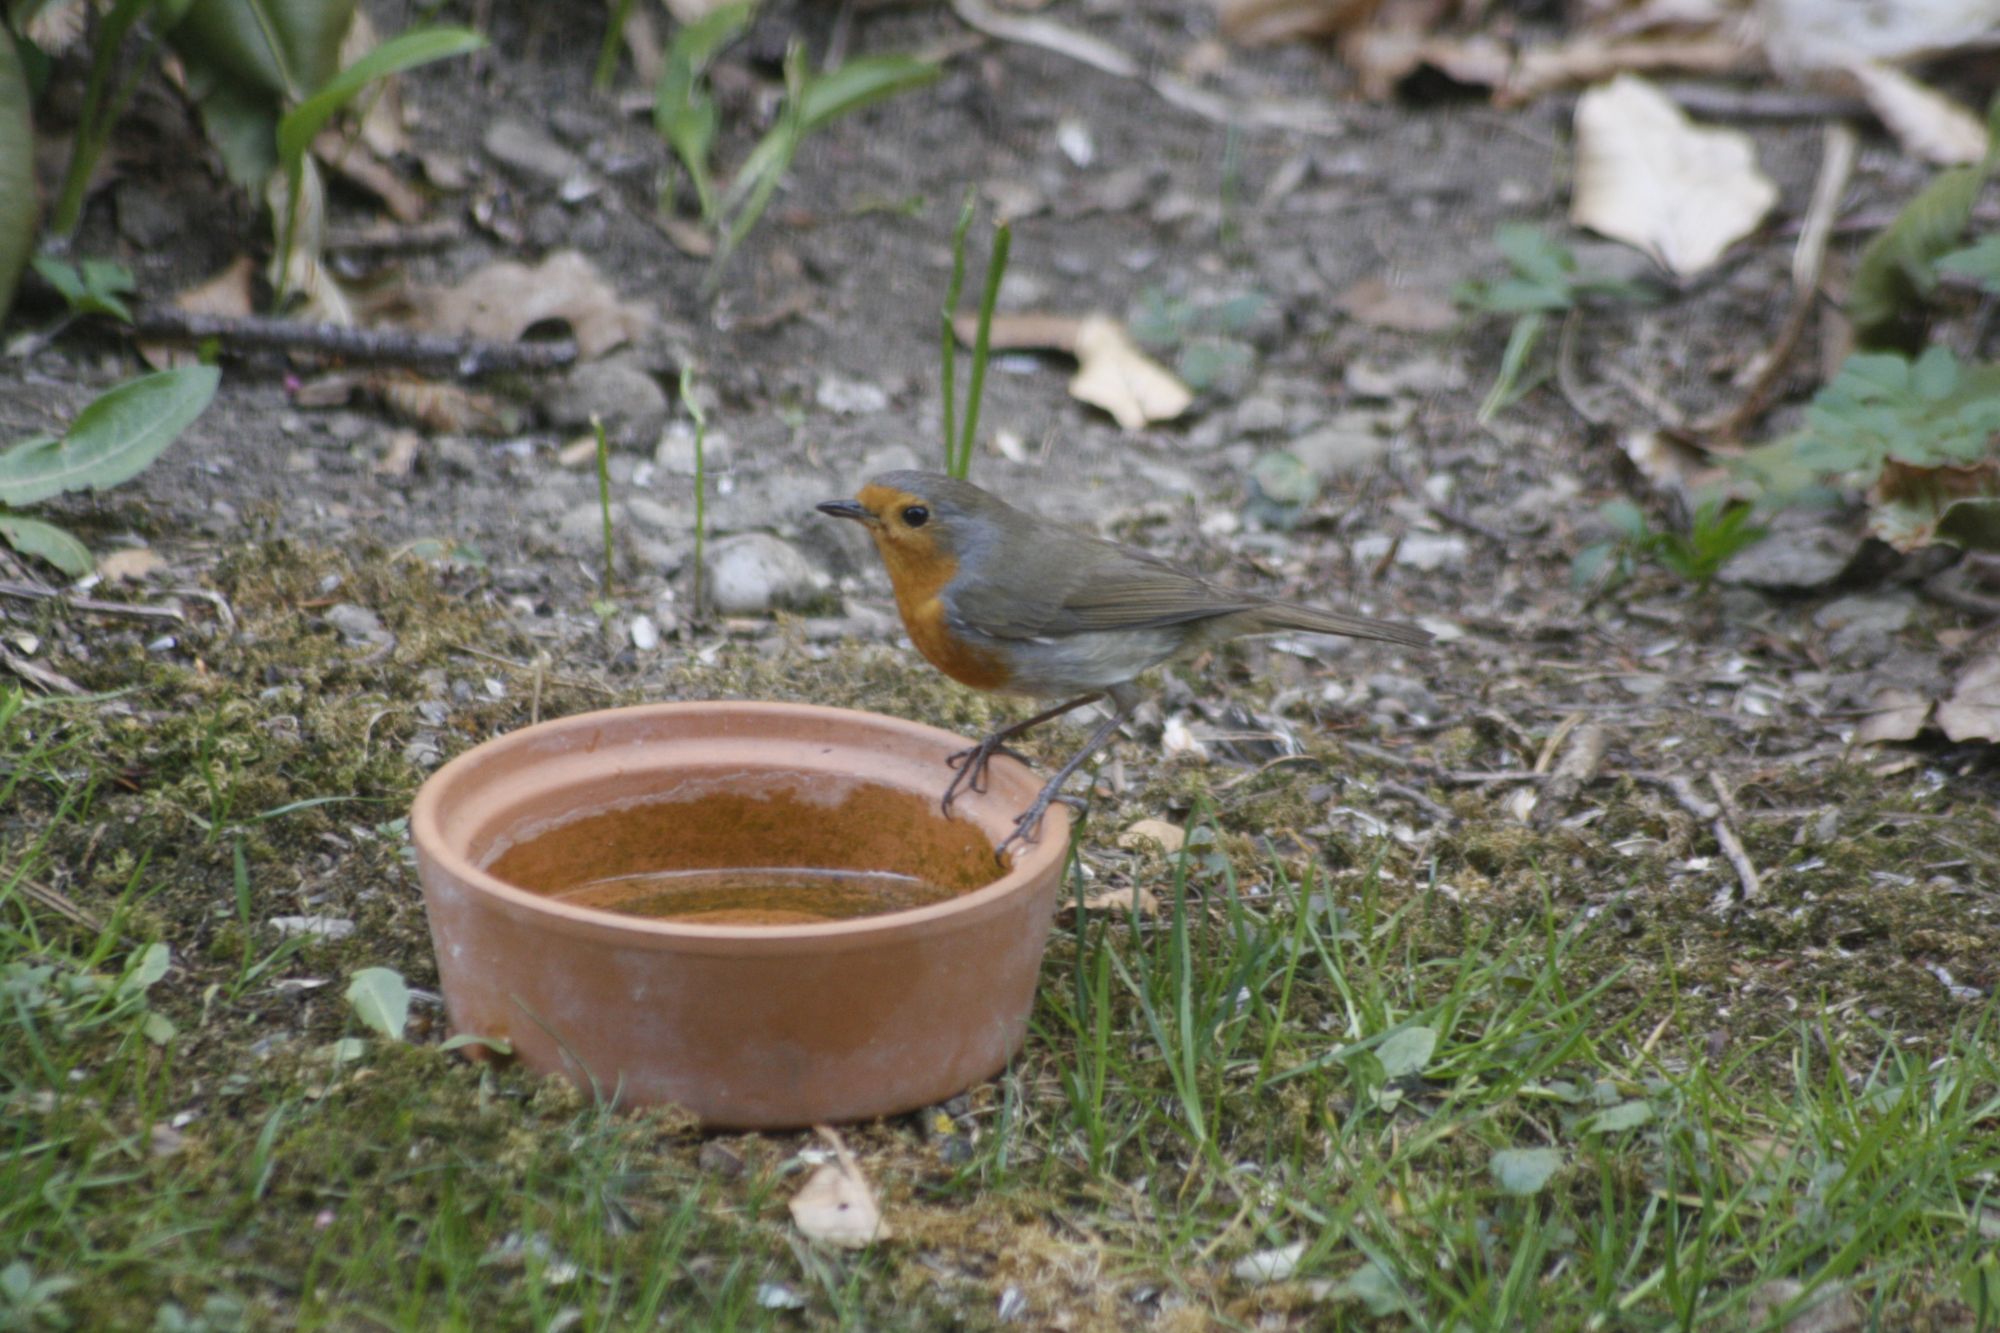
[820, 470, 1430, 855]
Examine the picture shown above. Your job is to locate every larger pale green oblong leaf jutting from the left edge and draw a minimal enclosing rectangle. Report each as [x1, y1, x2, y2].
[0, 366, 222, 504]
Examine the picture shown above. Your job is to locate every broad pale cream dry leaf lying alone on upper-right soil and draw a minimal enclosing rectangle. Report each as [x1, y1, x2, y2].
[1570, 74, 1778, 274]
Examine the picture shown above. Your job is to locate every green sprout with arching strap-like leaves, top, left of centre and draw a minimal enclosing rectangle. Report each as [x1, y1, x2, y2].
[652, 4, 938, 294]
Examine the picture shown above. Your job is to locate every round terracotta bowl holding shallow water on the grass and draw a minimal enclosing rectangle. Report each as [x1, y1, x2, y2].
[398, 703, 1068, 1129]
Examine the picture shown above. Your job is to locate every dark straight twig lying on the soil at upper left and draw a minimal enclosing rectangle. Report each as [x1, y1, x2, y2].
[132, 306, 576, 378]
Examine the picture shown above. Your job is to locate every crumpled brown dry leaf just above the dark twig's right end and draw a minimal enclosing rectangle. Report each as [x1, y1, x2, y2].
[416, 250, 652, 360]
